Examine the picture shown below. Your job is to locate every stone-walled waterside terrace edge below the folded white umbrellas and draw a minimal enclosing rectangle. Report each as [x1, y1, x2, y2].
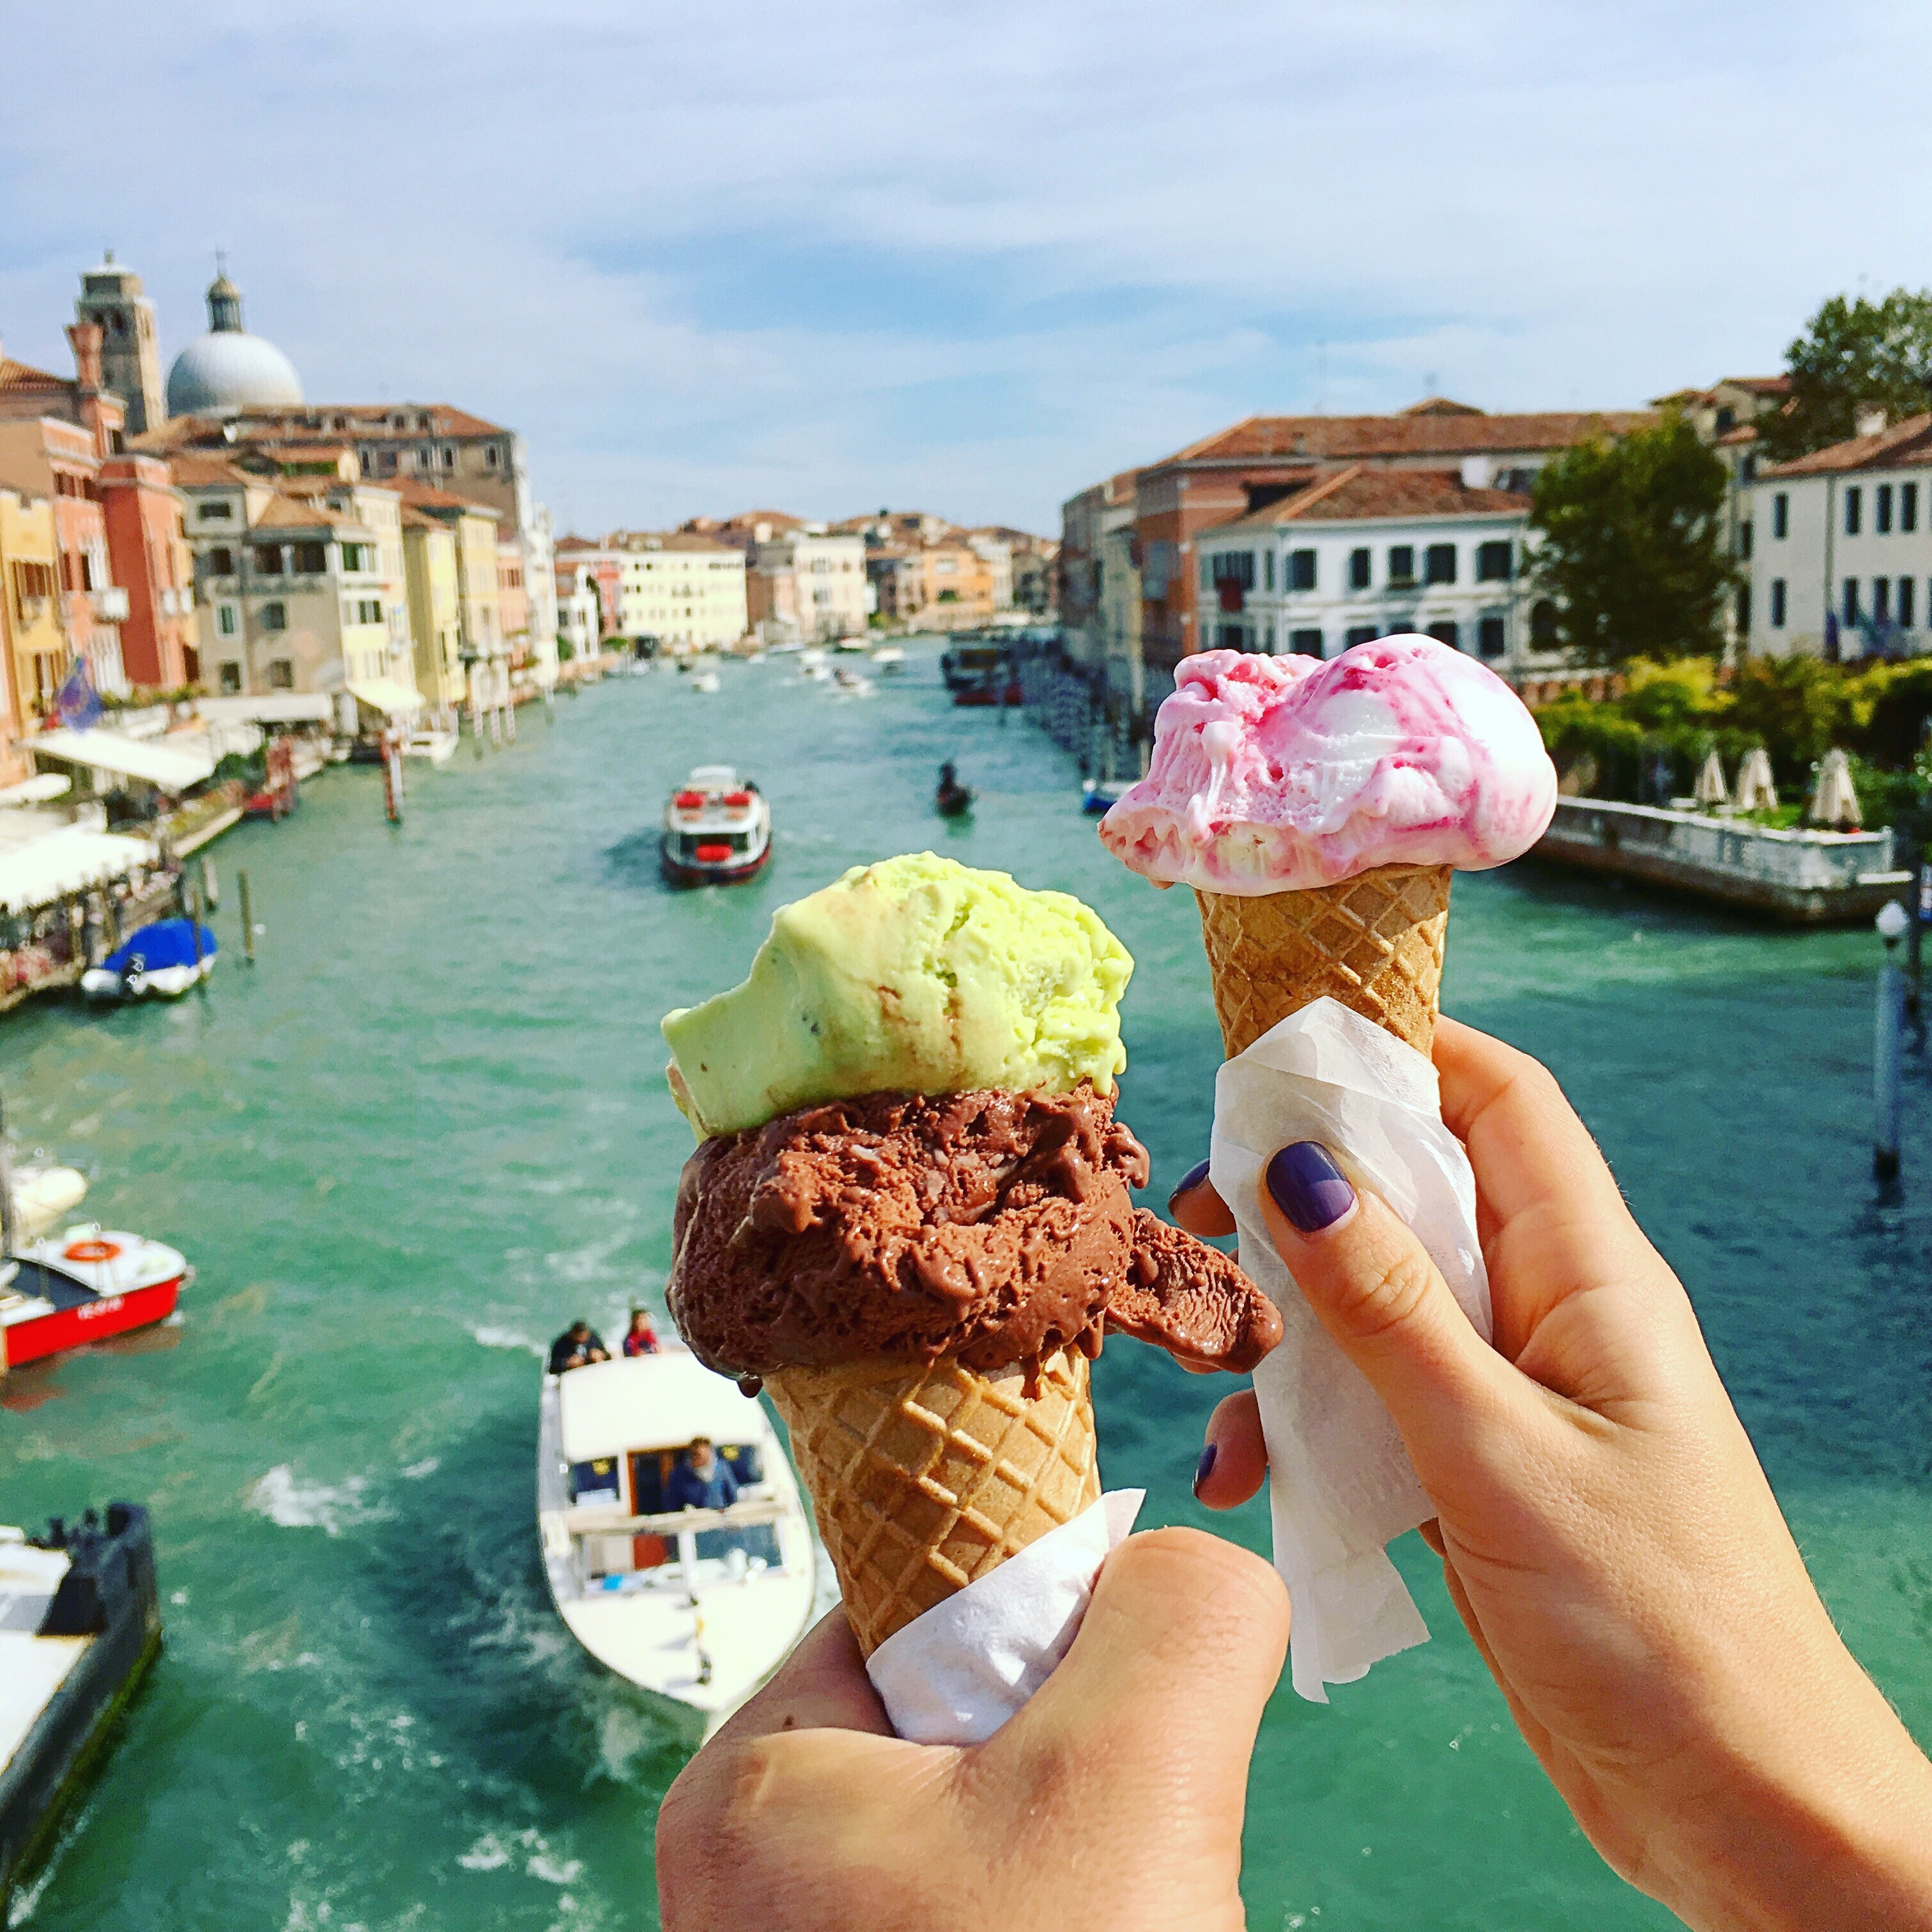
[1534, 798, 1913, 925]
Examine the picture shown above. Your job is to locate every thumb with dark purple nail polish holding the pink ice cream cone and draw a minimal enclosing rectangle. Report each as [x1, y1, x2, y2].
[1260, 1140, 1517, 1485]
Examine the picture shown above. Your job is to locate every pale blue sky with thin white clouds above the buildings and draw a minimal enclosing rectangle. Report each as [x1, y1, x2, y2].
[0, 0, 1932, 532]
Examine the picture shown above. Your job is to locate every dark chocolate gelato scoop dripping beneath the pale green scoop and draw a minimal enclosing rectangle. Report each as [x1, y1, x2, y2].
[668, 1085, 1281, 1379]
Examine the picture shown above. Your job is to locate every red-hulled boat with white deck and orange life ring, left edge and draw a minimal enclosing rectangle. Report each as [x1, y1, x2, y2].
[0, 1223, 195, 1374]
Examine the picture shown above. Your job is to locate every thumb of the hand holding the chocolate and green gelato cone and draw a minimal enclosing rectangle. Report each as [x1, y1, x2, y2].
[974, 1530, 1289, 1836]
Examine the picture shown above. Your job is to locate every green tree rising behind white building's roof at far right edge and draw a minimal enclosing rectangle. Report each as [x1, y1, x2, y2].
[1756, 288, 1932, 462]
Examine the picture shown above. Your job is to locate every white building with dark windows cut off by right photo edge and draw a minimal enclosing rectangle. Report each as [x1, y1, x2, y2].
[1743, 415, 1932, 659]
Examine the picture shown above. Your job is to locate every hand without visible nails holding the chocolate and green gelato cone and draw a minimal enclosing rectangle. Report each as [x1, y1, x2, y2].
[657, 1530, 1289, 1932]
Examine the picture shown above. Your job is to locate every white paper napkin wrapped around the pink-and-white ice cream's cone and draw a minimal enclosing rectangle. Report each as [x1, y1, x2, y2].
[1209, 999, 1492, 1704]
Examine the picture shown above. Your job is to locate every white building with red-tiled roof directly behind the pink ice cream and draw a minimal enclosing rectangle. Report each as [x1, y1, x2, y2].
[1196, 458, 1555, 670]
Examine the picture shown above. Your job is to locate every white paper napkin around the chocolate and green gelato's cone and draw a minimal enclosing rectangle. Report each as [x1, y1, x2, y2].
[866, 1490, 1147, 1745]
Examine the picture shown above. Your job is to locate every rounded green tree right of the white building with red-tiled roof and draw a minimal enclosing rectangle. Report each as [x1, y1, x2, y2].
[1530, 411, 1739, 664]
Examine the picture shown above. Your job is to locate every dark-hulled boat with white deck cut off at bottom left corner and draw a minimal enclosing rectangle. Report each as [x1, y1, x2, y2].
[0, 1503, 160, 1924]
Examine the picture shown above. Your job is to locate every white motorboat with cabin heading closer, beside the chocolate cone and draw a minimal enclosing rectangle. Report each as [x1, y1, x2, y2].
[537, 1347, 815, 1743]
